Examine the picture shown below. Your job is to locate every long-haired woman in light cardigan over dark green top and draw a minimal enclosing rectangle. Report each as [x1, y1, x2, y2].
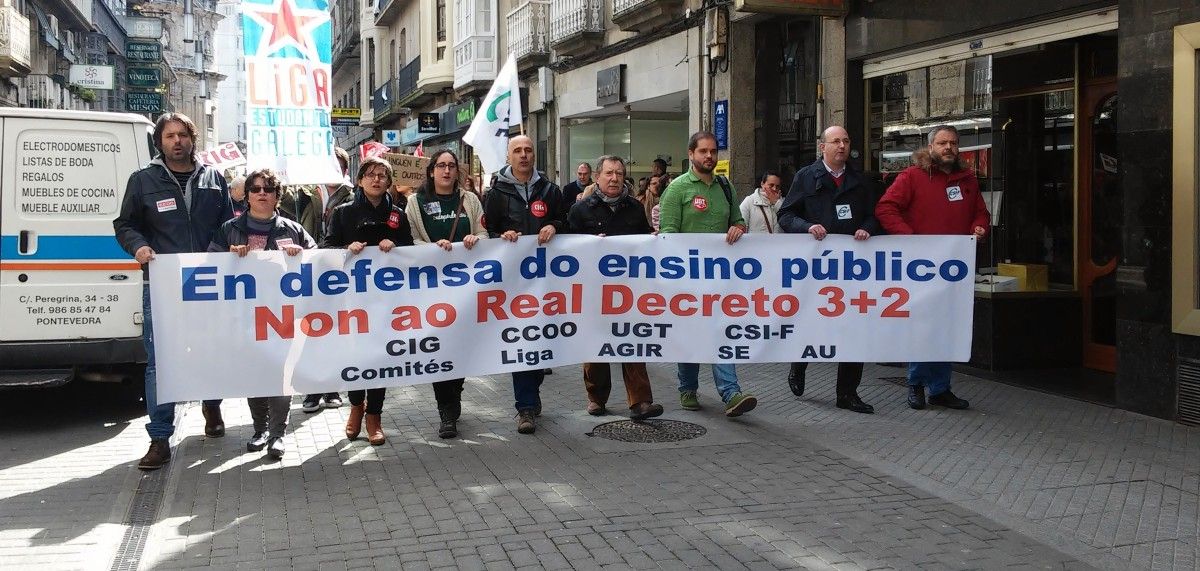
[406, 150, 487, 438]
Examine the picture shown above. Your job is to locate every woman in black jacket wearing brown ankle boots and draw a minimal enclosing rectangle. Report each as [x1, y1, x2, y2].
[320, 157, 413, 446]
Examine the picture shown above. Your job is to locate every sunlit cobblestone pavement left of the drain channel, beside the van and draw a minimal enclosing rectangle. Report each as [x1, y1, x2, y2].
[0, 383, 148, 569]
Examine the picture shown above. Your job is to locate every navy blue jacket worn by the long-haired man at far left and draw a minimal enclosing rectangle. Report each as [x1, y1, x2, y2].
[113, 157, 233, 278]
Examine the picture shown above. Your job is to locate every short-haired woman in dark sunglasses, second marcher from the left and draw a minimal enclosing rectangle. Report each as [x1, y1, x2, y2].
[209, 169, 317, 459]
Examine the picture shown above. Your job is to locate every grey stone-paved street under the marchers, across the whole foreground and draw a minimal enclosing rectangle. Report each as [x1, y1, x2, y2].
[0, 365, 1200, 570]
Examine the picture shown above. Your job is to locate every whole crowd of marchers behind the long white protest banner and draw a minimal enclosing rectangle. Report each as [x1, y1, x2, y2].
[113, 113, 989, 470]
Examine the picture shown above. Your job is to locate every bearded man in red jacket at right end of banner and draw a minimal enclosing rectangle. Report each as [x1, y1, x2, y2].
[875, 125, 990, 409]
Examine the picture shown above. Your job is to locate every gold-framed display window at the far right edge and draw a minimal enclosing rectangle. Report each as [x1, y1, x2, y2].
[1171, 23, 1200, 335]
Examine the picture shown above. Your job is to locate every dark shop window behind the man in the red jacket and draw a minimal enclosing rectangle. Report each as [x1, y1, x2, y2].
[865, 42, 1078, 291]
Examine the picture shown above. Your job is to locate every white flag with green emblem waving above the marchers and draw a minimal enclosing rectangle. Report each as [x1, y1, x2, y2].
[462, 54, 521, 173]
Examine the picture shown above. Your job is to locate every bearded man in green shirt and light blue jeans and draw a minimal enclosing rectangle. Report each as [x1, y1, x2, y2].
[659, 131, 758, 416]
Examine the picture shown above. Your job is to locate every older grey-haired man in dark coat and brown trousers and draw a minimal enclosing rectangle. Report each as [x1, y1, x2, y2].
[566, 155, 662, 420]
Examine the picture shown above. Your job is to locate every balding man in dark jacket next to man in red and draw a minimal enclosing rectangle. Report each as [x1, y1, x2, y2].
[779, 125, 883, 414]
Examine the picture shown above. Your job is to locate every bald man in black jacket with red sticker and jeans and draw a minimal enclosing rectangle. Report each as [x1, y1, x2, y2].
[484, 134, 570, 434]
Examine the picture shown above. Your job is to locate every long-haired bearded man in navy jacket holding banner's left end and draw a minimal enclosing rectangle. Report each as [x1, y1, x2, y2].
[113, 113, 233, 470]
